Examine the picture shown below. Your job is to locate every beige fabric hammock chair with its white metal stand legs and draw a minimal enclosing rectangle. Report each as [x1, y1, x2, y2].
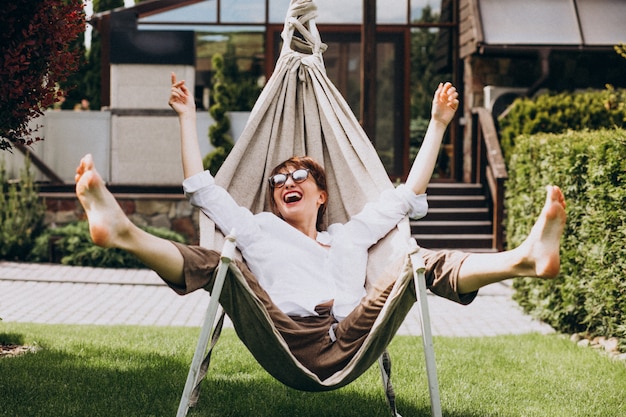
[178, 0, 441, 416]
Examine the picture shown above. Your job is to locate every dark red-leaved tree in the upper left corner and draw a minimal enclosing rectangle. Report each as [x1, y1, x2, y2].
[0, 0, 85, 150]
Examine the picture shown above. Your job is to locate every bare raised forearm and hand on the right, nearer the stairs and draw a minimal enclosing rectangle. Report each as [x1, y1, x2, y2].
[406, 83, 459, 194]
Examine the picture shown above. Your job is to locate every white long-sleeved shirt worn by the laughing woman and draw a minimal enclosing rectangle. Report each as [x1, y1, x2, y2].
[183, 171, 428, 320]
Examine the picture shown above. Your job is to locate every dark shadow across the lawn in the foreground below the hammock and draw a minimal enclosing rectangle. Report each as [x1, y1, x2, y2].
[0, 335, 478, 417]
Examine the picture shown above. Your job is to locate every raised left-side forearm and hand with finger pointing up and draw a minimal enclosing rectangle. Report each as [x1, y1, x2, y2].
[169, 73, 204, 178]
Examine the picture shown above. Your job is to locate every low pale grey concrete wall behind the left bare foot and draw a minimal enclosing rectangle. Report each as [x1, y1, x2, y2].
[0, 110, 224, 185]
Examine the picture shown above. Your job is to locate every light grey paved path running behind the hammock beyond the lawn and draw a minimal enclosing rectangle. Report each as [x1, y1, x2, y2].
[0, 261, 553, 336]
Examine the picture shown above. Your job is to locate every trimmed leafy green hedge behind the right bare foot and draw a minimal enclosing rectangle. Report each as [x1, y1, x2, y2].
[506, 129, 626, 345]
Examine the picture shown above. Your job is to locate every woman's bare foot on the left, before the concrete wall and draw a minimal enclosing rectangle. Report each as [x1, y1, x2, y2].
[75, 154, 130, 247]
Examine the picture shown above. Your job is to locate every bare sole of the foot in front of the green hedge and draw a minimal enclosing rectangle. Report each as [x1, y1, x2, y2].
[520, 186, 566, 278]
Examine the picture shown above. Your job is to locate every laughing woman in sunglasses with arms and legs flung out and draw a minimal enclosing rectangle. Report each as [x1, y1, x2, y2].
[76, 74, 565, 379]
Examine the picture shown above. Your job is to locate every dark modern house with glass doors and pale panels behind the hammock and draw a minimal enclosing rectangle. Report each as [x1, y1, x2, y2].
[6, 0, 626, 247]
